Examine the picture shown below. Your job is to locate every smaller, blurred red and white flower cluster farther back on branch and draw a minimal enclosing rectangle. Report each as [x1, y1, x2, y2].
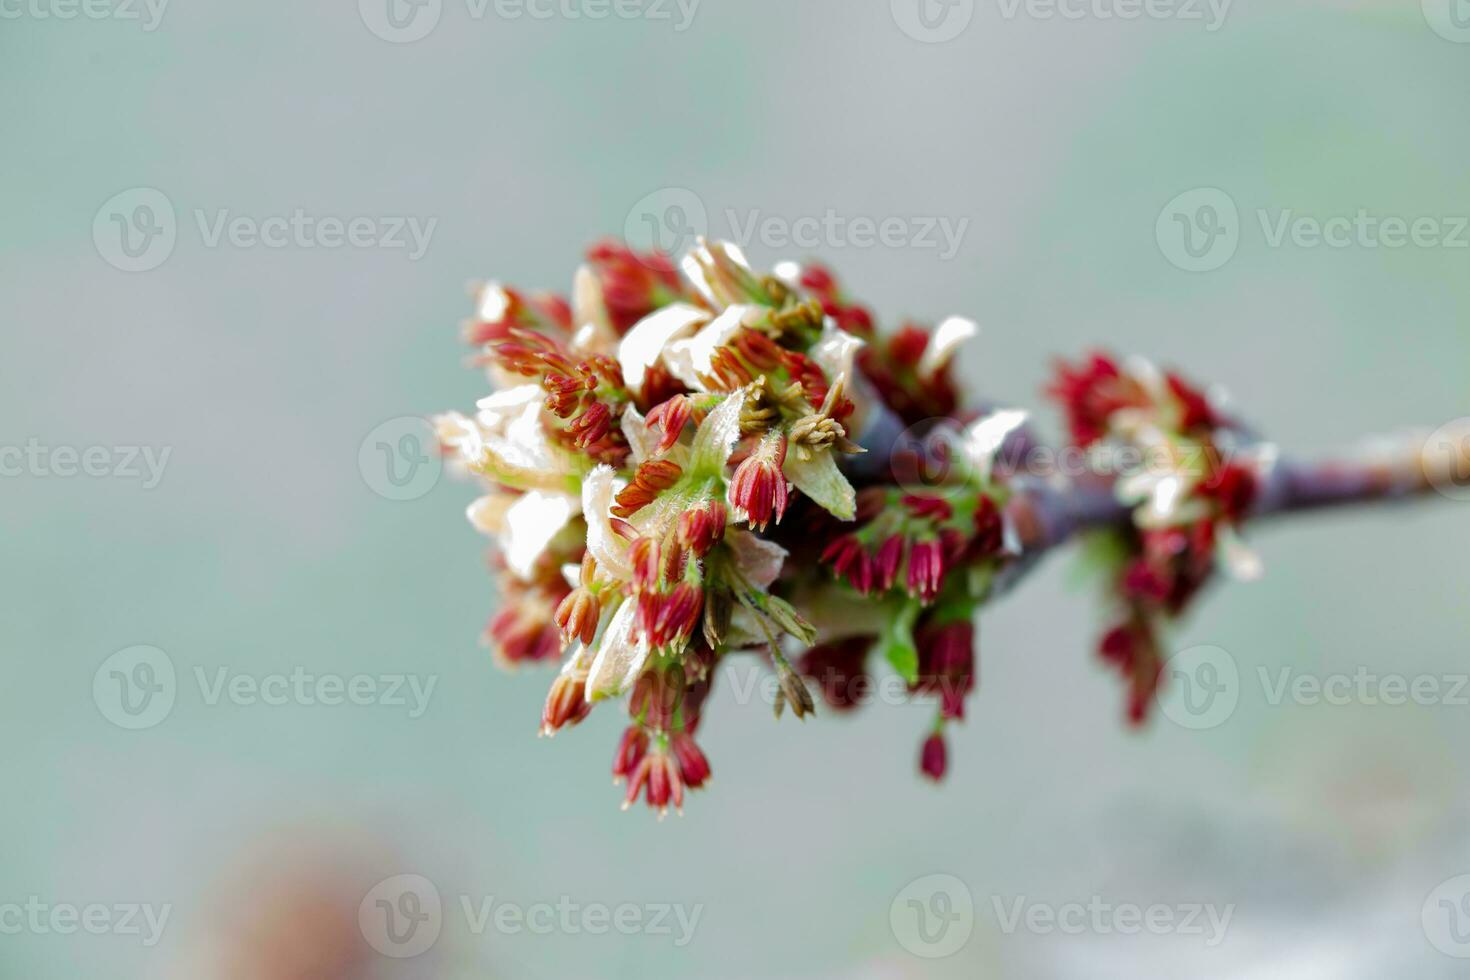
[1048, 354, 1273, 724]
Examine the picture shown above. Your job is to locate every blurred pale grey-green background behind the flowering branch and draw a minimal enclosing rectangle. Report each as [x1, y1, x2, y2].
[0, 0, 1470, 980]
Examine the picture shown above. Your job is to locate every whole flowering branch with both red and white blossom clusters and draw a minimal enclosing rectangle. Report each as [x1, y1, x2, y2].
[435, 241, 1470, 814]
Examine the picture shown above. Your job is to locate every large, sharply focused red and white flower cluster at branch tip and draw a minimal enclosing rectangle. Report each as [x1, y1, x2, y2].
[435, 241, 1023, 814]
